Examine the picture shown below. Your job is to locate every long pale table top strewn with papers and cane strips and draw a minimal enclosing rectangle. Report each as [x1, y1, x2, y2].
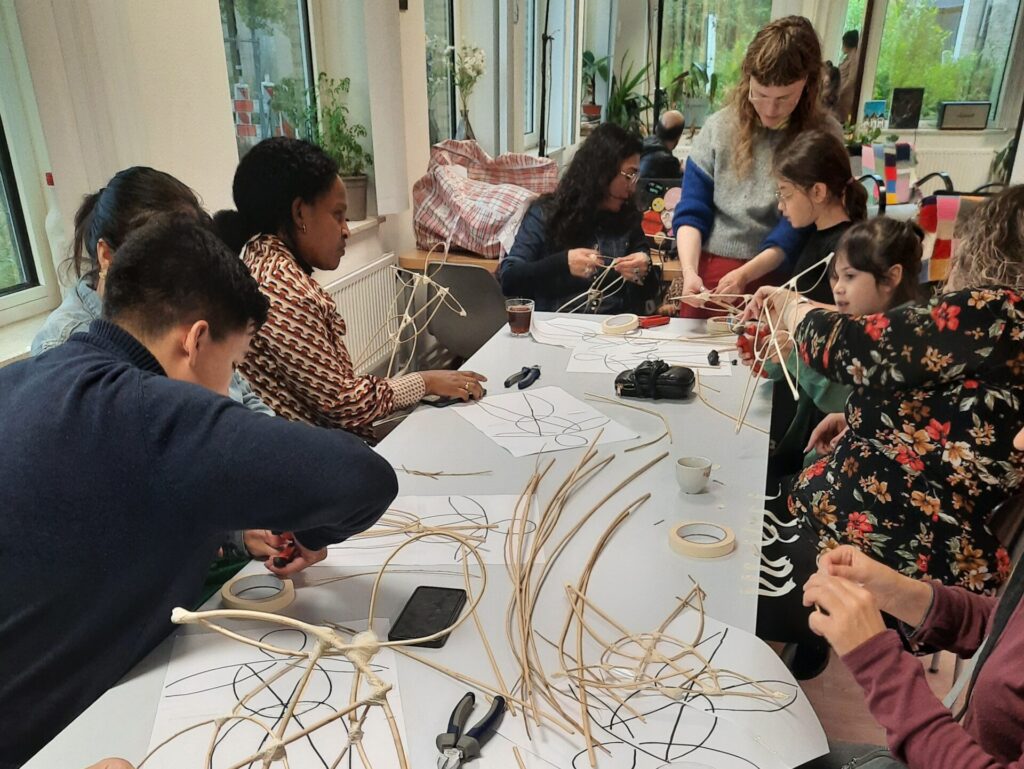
[27, 315, 770, 769]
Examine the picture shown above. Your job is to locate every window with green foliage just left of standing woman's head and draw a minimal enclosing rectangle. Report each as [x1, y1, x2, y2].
[660, 0, 771, 110]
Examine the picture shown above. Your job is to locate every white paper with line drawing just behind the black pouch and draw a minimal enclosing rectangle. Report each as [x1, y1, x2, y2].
[566, 334, 733, 377]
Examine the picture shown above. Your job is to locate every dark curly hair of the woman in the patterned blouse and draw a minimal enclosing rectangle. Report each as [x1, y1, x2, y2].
[213, 136, 338, 253]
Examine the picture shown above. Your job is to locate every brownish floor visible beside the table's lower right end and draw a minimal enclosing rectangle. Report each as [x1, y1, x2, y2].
[801, 652, 954, 744]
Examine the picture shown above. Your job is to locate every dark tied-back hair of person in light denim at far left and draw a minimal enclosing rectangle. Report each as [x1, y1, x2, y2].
[67, 166, 210, 288]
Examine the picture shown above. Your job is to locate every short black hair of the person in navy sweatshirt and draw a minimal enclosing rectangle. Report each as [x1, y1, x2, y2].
[103, 214, 269, 340]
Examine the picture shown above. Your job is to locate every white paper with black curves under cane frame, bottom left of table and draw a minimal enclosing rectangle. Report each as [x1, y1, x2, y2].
[146, 622, 408, 769]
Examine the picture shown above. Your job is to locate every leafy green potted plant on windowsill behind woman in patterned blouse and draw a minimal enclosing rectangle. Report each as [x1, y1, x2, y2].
[270, 72, 374, 220]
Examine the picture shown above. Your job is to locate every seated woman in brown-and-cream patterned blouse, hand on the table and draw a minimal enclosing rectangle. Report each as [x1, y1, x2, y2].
[214, 137, 485, 437]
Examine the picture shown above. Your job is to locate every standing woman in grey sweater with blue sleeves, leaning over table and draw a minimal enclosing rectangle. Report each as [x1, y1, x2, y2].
[664, 16, 843, 317]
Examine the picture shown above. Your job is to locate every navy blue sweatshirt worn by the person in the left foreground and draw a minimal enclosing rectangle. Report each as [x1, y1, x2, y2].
[0, 321, 397, 767]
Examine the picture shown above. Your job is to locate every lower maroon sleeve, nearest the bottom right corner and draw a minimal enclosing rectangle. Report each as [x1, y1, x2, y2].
[843, 630, 1024, 769]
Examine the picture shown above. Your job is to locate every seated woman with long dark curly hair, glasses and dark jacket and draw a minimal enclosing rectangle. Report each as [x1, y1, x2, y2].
[498, 123, 662, 314]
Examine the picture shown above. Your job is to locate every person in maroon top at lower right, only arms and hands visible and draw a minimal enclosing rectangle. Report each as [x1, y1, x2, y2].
[801, 540, 1024, 769]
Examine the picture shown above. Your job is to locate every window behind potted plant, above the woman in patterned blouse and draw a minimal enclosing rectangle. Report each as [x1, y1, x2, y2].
[220, 0, 314, 157]
